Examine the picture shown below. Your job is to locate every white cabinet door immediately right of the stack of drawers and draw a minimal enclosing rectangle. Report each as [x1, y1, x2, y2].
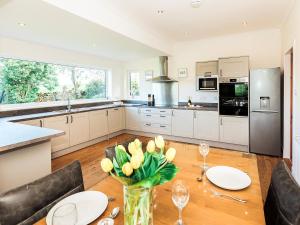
[172, 109, 194, 138]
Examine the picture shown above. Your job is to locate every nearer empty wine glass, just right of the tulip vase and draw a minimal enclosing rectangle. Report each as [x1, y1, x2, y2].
[172, 180, 189, 225]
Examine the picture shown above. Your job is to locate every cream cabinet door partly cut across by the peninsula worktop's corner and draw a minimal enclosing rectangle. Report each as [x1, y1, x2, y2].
[44, 116, 70, 152]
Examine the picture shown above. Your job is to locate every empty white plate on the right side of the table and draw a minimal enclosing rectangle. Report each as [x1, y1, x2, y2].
[206, 166, 251, 191]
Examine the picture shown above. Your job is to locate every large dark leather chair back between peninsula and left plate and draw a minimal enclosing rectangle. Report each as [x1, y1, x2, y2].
[0, 161, 84, 225]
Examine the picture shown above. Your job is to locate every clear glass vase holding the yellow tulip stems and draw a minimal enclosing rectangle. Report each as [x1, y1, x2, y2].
[123, 186, 153, 225]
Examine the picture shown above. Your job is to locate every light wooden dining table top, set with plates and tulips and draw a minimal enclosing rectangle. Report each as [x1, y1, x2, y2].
[36, 143, 265, 225]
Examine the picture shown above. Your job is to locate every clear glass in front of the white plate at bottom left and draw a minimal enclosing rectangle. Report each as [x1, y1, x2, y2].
[52, 203, 78, 225]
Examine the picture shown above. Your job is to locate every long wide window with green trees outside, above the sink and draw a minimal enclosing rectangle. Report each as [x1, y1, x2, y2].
[0, 58, 107, 104]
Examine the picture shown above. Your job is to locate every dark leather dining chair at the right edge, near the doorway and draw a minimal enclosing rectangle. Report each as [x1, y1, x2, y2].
[264, 161, 300, 225]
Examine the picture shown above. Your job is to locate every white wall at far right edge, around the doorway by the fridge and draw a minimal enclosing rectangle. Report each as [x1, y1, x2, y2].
[281, 1, 300, 184]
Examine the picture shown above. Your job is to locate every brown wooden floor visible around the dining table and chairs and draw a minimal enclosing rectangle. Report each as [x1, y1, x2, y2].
[52, 134, 280, 200]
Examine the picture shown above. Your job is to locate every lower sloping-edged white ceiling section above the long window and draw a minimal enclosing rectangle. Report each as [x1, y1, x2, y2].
[0, 0, 164, 61]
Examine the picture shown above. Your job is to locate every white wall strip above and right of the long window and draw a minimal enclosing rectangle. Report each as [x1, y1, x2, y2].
[0, 37, 124, 98]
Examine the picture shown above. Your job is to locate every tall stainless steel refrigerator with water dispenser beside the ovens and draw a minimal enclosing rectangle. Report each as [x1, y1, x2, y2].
[249, 68, 282, 156]
